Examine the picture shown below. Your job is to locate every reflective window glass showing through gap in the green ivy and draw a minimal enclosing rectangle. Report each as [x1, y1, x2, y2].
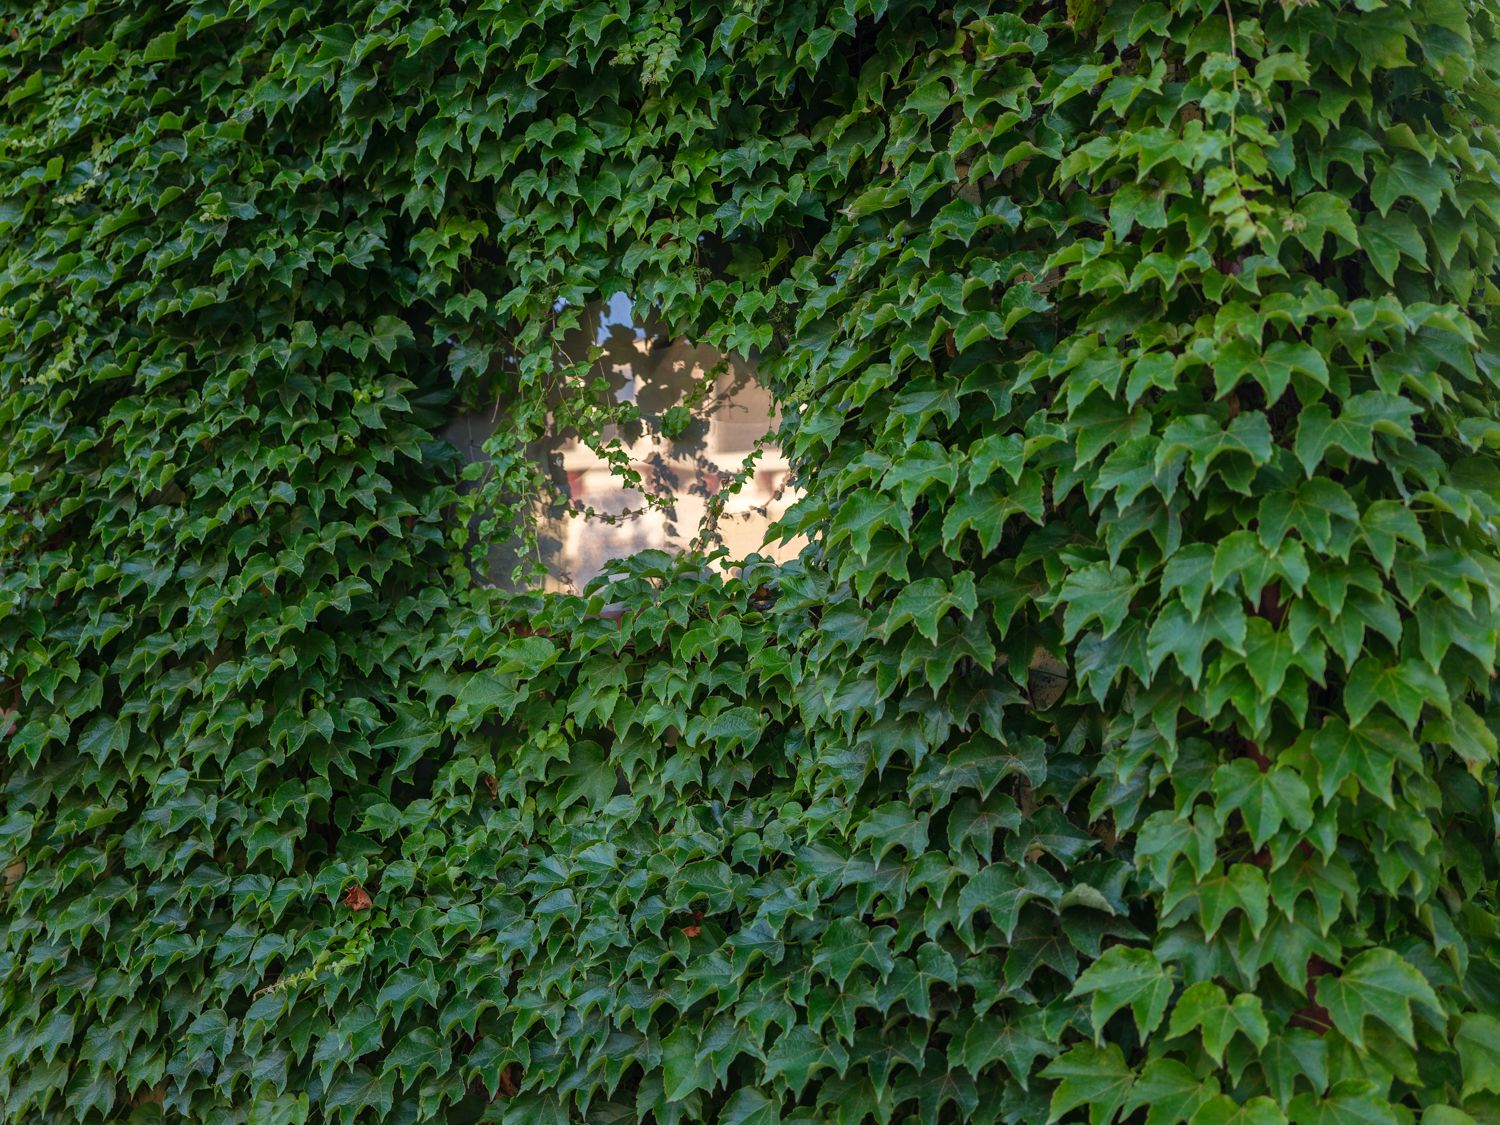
[446, 293, 804, 593]
